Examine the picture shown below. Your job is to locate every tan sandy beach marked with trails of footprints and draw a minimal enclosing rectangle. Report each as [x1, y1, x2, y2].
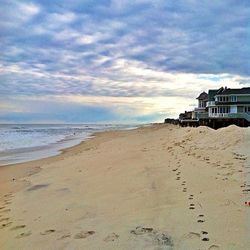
[0, 125, 250, 250]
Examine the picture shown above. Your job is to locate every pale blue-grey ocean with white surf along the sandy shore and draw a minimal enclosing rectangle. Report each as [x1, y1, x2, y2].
[0, 124, 138, 166]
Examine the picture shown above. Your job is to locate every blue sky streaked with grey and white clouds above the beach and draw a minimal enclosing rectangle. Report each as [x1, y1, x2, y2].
[0, 0, 250, 123]
